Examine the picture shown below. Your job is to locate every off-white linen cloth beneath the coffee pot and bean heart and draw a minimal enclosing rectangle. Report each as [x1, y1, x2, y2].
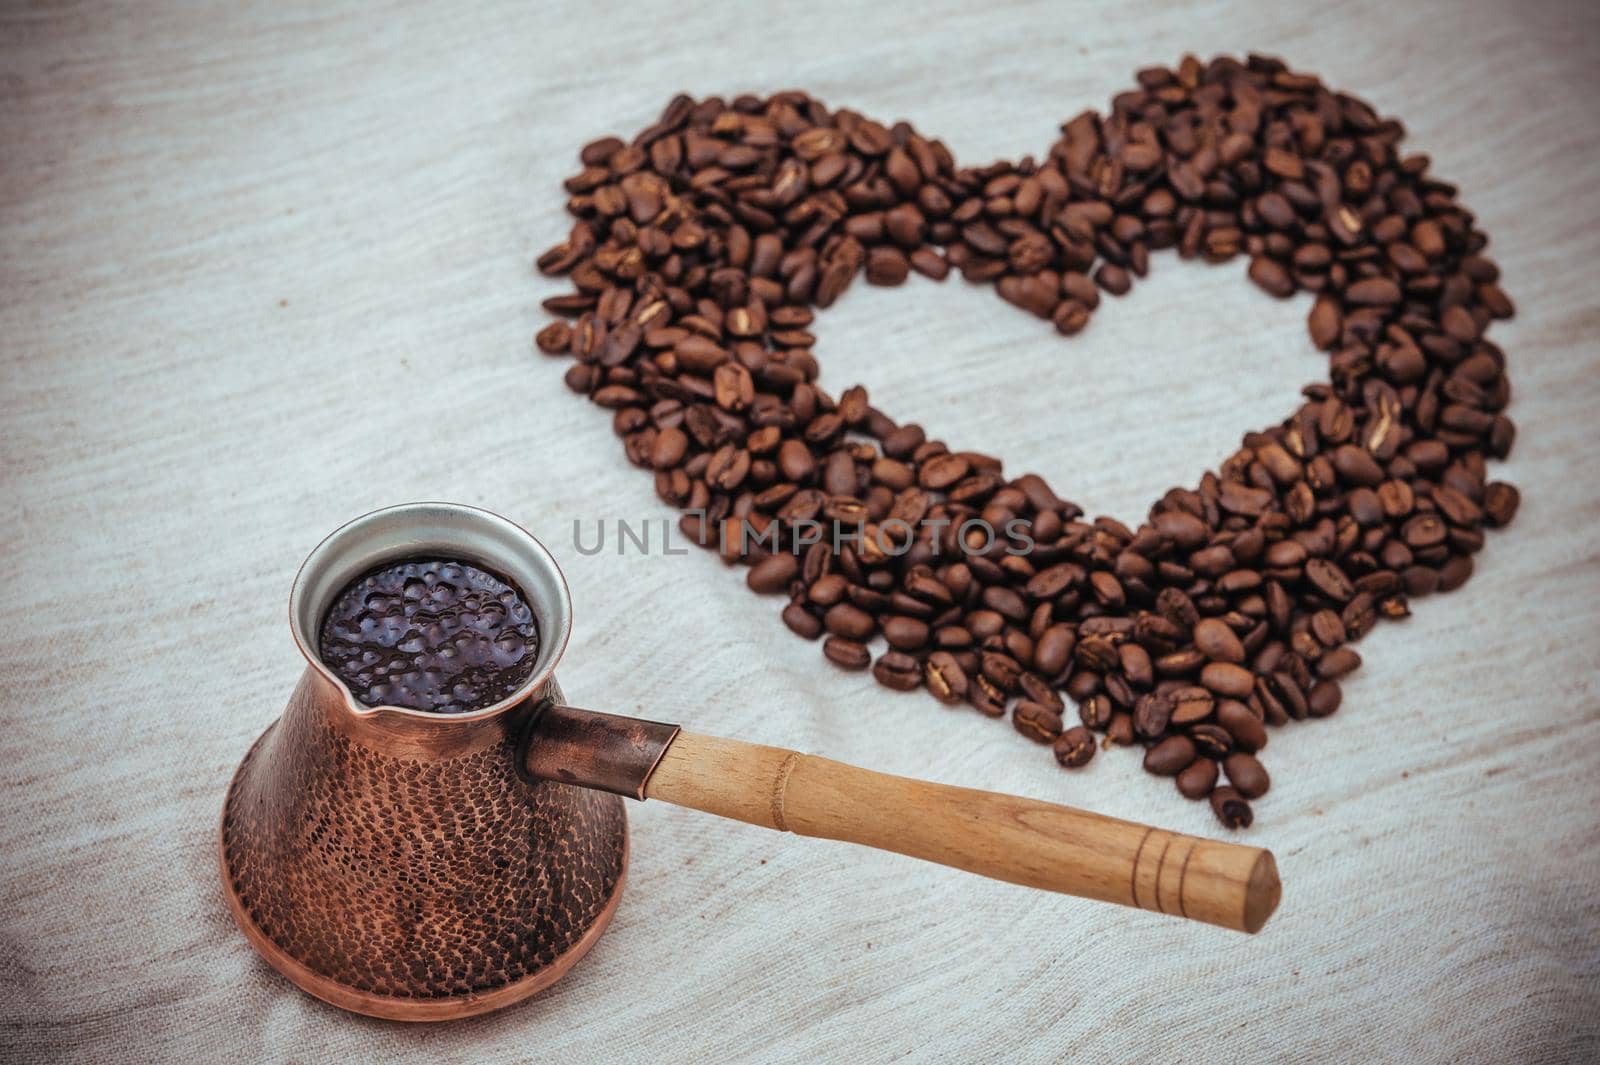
[0, 0, 1600, 1063]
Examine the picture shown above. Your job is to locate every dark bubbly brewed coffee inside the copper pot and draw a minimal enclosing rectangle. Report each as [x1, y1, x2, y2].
[317, 558, 539, 713]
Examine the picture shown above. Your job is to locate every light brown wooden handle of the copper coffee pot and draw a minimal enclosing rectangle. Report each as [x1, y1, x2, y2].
[645, 732, 1278, 932]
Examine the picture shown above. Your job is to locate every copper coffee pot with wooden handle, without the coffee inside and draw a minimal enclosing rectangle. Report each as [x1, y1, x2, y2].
[221, 504, 1278, 1020]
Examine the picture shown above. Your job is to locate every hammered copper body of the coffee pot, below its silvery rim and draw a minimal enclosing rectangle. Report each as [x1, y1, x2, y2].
[222, 670, 627, 1015]
